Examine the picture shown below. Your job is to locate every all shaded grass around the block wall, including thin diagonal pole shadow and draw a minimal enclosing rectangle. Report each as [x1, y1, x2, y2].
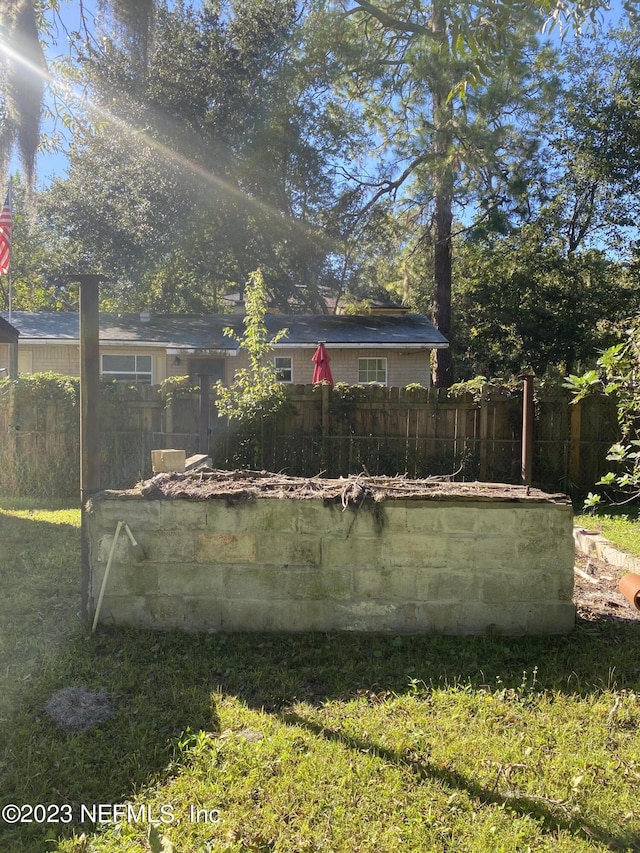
[0, 502, 640, 853]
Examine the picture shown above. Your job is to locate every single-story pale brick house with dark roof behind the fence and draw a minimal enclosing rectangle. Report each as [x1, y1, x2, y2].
[0, 311, 449, 386]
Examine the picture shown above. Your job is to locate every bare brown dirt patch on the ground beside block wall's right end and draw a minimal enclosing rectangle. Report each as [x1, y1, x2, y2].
[573, 551, 640, 622]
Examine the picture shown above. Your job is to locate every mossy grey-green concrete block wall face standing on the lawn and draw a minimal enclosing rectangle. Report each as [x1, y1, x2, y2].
[86, 493, 575, 634]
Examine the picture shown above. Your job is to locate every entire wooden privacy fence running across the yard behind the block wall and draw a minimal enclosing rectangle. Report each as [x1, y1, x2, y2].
[0, 376, 618, 495]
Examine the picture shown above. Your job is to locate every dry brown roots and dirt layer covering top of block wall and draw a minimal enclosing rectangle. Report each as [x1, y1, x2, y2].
[129, 468, 568, 504]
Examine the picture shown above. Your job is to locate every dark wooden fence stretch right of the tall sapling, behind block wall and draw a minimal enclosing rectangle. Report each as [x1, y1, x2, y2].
[204, 385, 618, 493]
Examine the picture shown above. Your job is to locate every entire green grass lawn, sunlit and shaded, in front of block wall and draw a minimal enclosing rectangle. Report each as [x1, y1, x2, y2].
[0, 501, 640, 853]
